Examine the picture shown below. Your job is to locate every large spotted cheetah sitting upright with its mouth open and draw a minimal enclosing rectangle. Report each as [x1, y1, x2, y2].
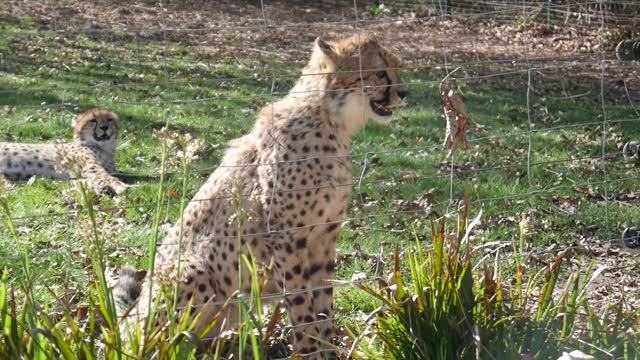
[116, 35, 407, 358]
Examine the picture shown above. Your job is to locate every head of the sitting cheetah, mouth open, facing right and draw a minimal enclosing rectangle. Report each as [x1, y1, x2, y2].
[311, 34, 408, 128]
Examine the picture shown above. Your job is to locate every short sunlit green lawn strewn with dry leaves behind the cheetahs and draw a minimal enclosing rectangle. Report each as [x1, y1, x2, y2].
[0, 7, 640, 358]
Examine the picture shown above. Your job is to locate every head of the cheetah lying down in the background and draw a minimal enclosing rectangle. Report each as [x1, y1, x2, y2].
[73, 109, 120, 149]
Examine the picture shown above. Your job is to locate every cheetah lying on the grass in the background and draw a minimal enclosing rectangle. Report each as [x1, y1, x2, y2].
[0, 109, 128, 195]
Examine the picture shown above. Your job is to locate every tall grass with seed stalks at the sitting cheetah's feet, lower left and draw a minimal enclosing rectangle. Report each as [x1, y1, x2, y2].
[0, 131, 274, 359]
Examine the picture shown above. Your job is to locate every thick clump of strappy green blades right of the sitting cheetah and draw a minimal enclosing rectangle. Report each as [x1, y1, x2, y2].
[352, 198, 640, 359]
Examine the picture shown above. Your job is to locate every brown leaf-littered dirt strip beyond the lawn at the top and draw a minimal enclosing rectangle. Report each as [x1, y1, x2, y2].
[5, 0, 640, 101]
